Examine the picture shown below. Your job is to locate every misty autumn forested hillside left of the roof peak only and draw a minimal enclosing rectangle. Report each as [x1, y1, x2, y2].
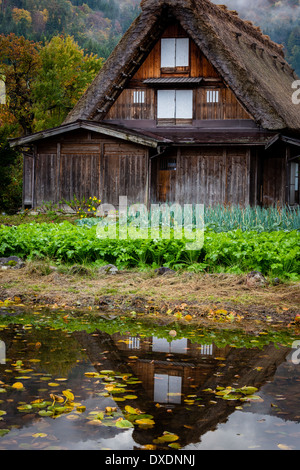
[0, 0, 139, 58]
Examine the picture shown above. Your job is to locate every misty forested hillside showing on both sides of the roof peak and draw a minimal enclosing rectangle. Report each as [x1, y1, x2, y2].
[0, 0, 300, 75]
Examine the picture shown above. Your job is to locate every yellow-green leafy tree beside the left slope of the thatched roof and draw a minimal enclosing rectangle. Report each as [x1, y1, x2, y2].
[33, 36, 103, 130]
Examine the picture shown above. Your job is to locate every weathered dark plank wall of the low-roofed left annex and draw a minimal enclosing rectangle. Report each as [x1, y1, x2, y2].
[32, 131, 148, 206]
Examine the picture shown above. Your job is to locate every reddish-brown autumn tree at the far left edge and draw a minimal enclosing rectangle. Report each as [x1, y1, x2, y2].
[0, 34, 40, 135]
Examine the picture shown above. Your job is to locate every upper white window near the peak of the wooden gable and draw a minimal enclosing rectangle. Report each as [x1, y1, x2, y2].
[161, 38, 189, 68]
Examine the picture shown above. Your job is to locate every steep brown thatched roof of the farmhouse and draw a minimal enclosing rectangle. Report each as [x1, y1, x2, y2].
[65, 0, 300, 130]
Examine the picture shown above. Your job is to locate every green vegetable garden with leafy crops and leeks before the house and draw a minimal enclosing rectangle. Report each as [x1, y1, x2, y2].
[0, 207, 300, 281]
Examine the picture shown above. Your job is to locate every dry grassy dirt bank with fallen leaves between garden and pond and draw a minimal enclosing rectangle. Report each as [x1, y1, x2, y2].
[0, 264, 300, 325]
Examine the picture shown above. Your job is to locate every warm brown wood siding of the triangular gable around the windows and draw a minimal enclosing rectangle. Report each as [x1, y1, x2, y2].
[105, 24, 251, 120]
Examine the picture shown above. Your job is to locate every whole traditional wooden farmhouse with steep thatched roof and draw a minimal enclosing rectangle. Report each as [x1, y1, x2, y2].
[11, 0, 300, 207]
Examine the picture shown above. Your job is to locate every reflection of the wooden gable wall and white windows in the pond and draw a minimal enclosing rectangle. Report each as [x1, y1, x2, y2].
[113, 335, 230, 405]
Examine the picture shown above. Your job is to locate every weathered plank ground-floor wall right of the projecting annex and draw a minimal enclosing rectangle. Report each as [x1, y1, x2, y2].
[151, 147, 250, 206]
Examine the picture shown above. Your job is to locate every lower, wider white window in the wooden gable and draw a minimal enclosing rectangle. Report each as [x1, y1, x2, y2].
[157, 90, 193, 119]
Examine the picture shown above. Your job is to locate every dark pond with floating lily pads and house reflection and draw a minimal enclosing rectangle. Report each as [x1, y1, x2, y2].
[0, 309, 300, 452]
